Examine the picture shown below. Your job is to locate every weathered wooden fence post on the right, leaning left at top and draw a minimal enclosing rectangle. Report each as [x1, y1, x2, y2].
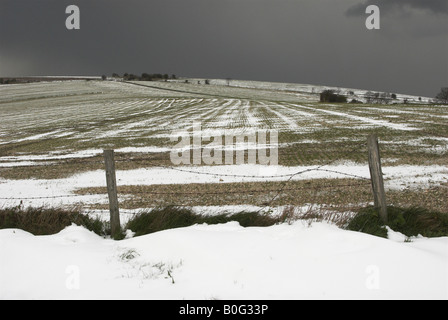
[367, 134, 387, 223]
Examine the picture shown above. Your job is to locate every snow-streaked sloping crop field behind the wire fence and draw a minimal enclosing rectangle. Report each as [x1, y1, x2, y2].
[0, 81, 448, 212]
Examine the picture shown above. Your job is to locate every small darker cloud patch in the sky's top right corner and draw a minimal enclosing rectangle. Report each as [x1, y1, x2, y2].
[346, 0, 448, 16]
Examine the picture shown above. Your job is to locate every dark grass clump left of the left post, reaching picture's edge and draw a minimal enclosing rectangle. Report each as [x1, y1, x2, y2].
[0, 206, 107, 236]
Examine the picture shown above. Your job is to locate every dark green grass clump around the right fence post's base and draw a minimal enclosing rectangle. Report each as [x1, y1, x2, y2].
[347, 206, 448, 238]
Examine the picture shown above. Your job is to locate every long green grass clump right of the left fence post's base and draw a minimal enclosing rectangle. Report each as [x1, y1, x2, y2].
[124, 207, 278, 236]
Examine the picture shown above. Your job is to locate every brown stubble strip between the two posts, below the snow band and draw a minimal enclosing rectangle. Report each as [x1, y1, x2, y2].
[76, 178, 371, 209]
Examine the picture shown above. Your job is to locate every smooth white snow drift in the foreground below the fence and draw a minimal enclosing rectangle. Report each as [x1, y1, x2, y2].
[0, 221, 448, 299]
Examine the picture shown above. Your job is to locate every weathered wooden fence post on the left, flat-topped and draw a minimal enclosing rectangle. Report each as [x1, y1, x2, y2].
[103, 150, 121, 238]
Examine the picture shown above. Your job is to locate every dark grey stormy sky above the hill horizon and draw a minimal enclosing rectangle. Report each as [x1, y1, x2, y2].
[0, 0, 448, 97]
